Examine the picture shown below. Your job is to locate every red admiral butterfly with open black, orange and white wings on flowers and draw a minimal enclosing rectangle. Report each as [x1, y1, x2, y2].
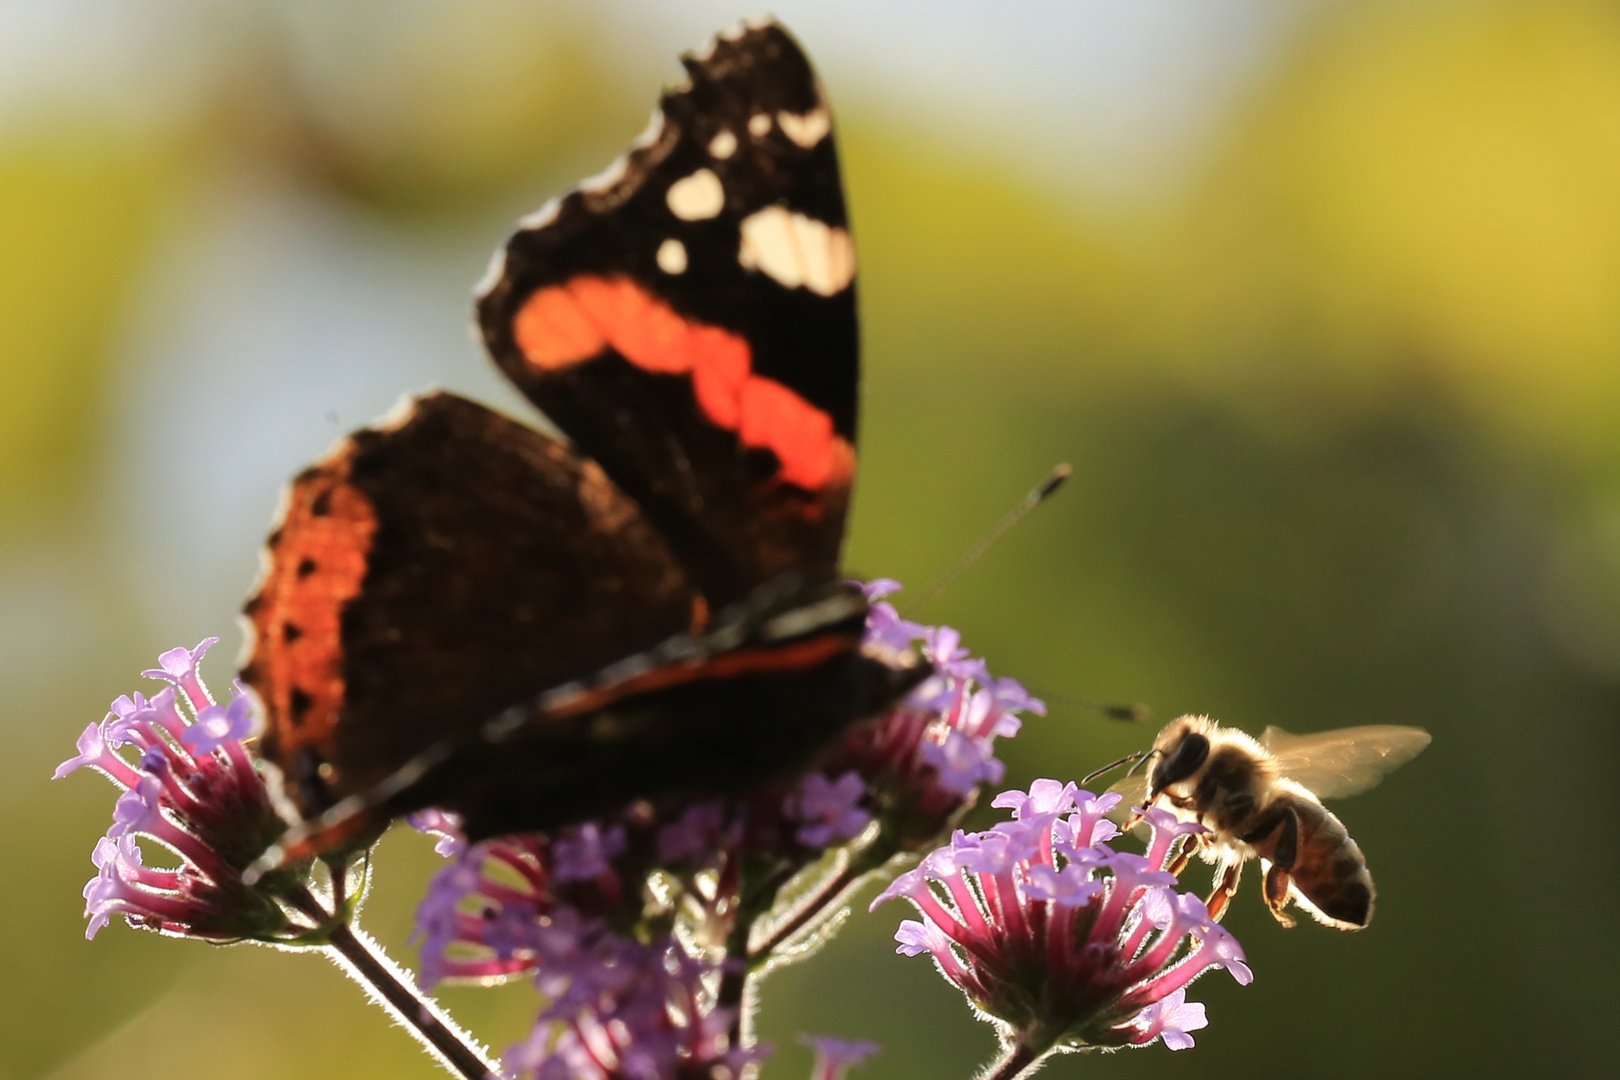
[241, 21, 927, 860]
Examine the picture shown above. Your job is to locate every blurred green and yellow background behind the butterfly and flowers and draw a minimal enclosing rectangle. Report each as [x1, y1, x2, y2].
[0, 0, 1620, 1080]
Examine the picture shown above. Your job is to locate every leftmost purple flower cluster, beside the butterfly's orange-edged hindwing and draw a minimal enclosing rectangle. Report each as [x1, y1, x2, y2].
[55, 638, 301, 941]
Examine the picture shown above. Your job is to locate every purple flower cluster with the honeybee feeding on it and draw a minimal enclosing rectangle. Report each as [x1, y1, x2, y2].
[872, 780, 1252, 1057]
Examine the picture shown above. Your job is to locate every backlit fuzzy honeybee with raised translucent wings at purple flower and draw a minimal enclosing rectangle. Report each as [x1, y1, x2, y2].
[1094, 716, 1429, 929]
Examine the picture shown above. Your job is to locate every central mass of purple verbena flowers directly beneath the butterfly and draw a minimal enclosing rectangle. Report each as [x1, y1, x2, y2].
[403, 581, 1042, 1080]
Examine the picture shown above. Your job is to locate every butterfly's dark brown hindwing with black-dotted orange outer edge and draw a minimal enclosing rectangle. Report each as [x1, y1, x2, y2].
[241, 393, 697, 814]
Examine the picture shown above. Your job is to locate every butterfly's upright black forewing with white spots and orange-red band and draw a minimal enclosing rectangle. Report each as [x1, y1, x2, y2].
[478, 24, 859, 607]
